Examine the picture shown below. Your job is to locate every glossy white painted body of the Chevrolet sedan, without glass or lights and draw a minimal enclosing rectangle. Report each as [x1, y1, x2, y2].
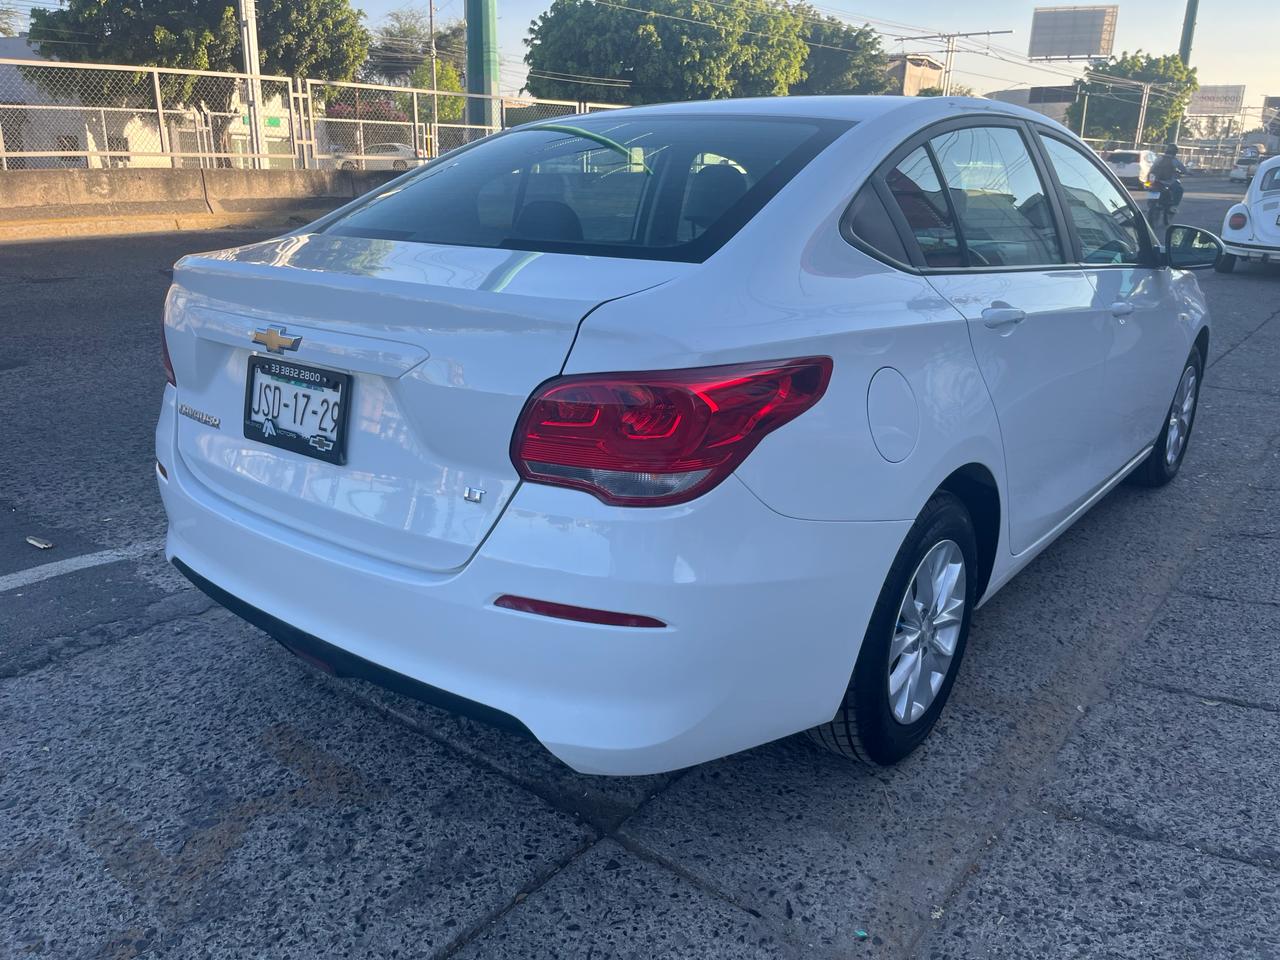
[156, 97, 1207, 774]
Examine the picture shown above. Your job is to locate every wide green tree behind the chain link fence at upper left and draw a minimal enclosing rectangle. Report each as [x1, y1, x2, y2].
[31, 0, 369, 81]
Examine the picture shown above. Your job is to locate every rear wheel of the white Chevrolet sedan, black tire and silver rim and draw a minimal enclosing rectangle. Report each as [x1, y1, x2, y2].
[808, 492, 978, 765]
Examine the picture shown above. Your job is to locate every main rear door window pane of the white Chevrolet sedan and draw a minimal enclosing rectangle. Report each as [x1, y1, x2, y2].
[929, 127, 1064, 268]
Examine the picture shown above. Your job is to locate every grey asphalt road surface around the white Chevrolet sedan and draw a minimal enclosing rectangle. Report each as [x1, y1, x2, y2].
[0, 182, 1280, 960]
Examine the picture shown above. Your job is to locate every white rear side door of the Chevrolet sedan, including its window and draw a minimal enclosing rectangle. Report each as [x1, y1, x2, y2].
[886, 119, 1111, 553]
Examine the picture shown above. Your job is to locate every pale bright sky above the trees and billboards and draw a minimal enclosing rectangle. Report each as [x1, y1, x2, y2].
[353, 0, 1280, 120]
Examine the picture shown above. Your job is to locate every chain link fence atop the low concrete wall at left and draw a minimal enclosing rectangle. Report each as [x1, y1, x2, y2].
[0, 59, 614, 170]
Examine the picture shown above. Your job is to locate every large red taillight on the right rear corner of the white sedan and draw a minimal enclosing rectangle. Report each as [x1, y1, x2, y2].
[511, 357, 831, 507]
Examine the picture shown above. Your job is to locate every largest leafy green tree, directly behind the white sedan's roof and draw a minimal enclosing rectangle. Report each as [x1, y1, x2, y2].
[525, 0, 808, 104]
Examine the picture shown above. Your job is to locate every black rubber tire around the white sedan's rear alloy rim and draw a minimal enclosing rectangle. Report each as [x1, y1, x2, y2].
[806, 492, 978, 767]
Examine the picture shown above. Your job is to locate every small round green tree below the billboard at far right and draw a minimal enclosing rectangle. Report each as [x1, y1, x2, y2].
[1066, 50, 1199, 143]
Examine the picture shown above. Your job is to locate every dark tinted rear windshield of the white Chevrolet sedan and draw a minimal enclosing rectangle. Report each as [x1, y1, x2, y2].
[325, 113, 852, 262]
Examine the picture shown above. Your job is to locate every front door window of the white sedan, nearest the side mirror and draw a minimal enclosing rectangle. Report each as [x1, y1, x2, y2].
[1041, 134, 1142, 264]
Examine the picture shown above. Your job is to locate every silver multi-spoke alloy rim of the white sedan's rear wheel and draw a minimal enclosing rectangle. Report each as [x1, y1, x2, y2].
[888, 540, 968, 723]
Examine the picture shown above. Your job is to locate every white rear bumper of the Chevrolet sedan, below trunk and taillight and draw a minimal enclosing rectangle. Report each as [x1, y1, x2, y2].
[157, 390, 910, 774]
